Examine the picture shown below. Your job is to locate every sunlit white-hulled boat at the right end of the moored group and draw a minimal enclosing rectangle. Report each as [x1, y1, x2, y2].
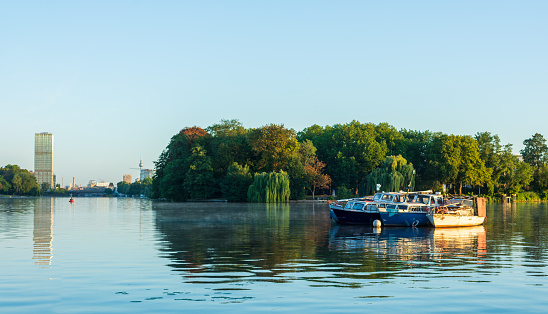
[426, 196, 487, 227]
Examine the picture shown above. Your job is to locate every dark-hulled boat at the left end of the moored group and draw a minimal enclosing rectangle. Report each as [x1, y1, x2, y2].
[329, 192, 405, 225]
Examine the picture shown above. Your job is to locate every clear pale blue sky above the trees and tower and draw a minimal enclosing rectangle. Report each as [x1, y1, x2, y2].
[0, 0, 548, 185]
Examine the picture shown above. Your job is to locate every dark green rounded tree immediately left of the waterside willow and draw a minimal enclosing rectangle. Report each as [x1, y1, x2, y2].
[221, 162, 253, 202]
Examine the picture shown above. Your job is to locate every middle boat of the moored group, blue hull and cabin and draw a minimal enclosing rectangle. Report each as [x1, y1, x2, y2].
[377, 191, 443, 227]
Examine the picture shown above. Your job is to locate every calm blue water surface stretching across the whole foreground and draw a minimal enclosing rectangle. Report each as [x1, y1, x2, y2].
[0, 198, 548, 313]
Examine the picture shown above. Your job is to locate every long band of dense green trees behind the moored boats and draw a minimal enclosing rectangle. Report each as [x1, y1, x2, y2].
[152, 120, 548, 202]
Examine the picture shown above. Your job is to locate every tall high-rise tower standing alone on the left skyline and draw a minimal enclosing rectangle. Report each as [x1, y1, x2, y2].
[34, 132, 55, 189]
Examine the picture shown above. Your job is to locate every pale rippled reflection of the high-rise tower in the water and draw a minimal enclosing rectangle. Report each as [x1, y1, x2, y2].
[32, 198, 53, 266]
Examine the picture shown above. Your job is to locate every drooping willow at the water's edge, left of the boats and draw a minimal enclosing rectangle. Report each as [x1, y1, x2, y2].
[247, 171, 291, 203]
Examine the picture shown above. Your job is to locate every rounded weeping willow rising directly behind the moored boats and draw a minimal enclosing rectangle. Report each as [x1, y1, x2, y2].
[360, 155, 415, 195]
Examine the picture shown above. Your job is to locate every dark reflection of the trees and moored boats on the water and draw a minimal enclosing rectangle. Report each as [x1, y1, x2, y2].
[154, 203, 548, 287]
